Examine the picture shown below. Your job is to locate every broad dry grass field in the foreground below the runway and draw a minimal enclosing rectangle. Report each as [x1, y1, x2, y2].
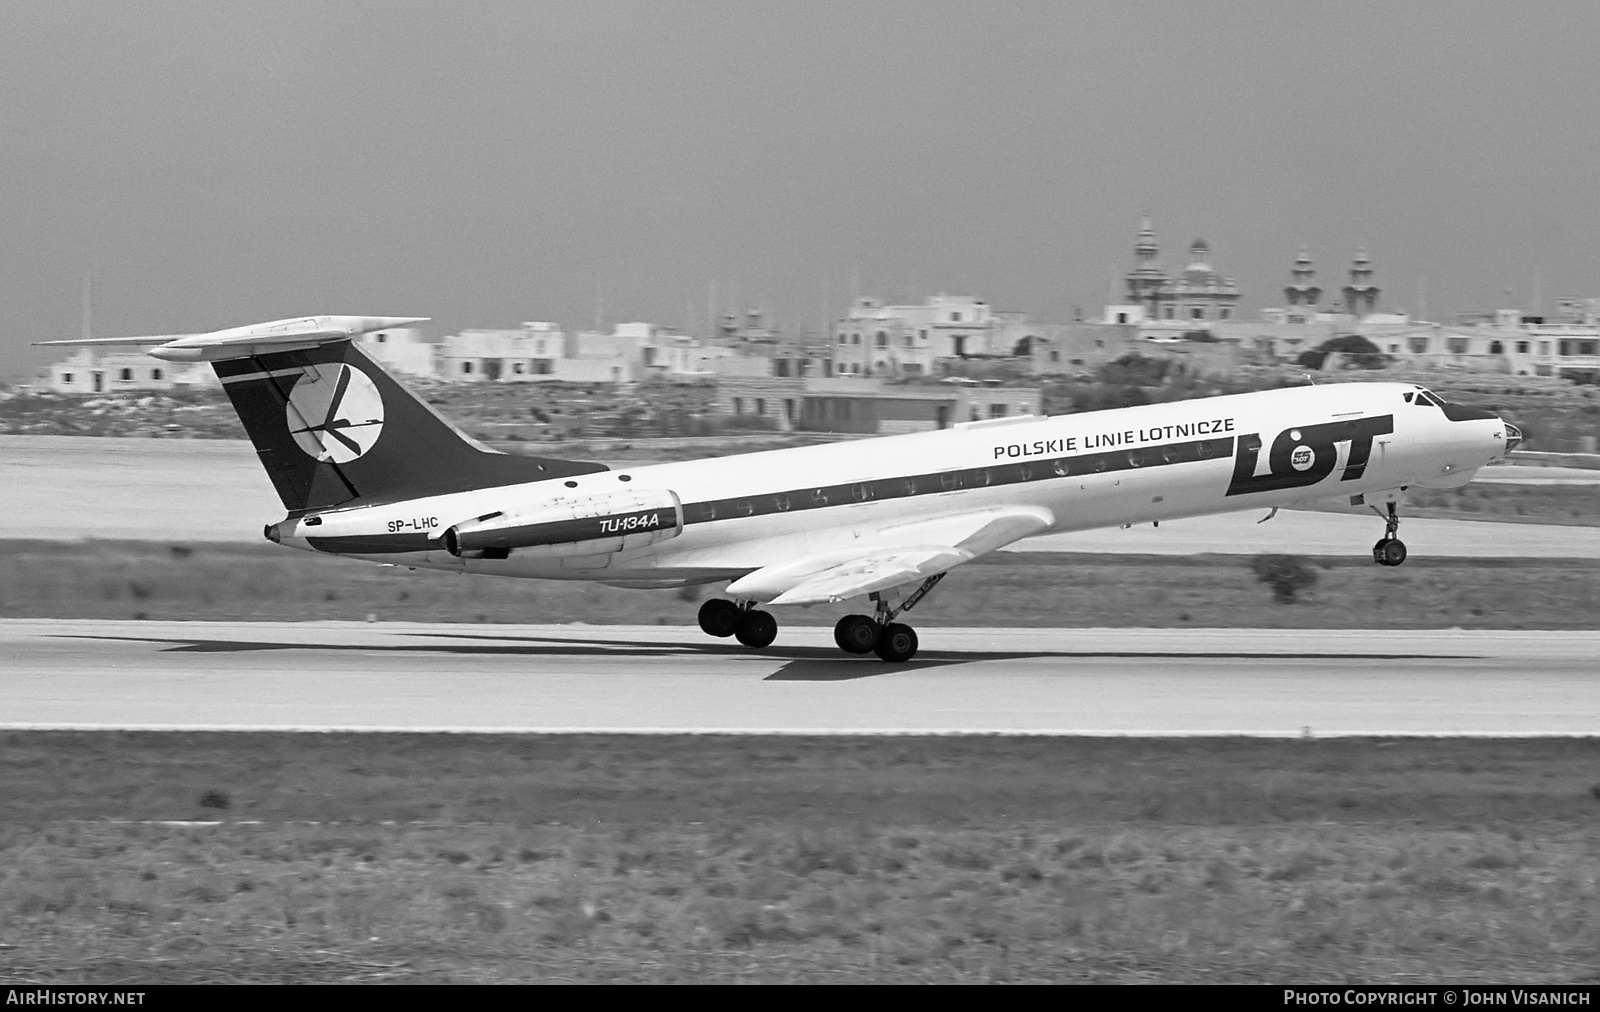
[0, 732, 1600, 983]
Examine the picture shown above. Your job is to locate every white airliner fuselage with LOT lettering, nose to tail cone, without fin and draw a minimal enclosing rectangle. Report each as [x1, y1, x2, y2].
[278, 383, 1506, 602]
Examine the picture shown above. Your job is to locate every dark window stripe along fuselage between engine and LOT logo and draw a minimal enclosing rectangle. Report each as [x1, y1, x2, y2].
[683, 436, 1234, 525]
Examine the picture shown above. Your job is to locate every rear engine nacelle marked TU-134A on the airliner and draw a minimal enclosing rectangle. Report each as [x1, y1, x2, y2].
[443, 490, 683, 559]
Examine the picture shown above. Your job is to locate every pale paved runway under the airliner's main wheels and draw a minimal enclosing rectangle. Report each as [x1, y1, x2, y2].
[0, 620, 1600, 737]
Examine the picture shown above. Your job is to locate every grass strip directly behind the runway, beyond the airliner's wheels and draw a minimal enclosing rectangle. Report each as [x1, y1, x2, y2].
[0, 541, 1600, 629]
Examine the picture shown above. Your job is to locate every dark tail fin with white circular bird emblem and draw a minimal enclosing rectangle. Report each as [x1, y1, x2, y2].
[213, 339, 606, 514]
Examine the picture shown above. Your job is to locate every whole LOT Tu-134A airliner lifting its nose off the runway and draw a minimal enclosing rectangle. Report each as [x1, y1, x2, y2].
[34, 317, 1522, 661]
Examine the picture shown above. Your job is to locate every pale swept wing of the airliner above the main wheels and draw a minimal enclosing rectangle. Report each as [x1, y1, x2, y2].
[728, 506, 1054, 604]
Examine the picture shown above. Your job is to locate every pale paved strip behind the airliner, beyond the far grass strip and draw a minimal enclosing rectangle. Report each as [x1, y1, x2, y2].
[0, 436, 1600, 559]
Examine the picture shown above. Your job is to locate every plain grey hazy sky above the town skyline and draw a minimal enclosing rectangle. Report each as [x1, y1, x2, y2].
[0, 0, 1600, 375]
